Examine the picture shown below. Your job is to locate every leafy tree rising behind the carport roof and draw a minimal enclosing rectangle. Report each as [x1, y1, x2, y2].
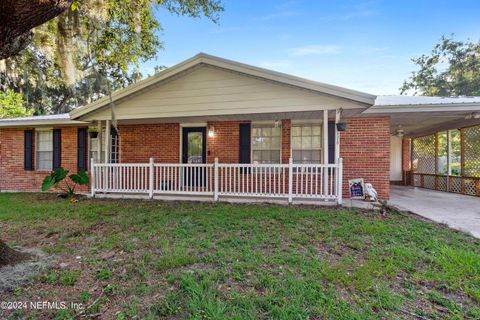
[400, 36, 480, 97]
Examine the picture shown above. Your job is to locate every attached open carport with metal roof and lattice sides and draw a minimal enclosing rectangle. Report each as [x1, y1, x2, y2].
[364, 96, 480, 196]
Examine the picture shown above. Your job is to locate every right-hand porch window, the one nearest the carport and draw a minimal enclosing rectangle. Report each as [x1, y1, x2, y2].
[292, 124, 322, 163]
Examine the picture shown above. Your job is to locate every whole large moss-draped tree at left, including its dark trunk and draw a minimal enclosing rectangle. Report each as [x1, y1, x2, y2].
[0, 0, 223, 266]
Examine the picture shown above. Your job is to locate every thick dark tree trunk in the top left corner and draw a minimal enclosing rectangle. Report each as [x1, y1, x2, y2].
[0, 0, 73, 60]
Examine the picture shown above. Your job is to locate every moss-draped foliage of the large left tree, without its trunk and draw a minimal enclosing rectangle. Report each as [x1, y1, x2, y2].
[0, 0, 223, 114]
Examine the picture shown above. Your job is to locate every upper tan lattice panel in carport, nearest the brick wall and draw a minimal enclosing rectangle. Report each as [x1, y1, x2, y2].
[412, 135, 436, 175]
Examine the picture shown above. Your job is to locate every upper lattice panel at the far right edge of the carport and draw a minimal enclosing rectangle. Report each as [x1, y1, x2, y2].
[463, 126, 480, 178]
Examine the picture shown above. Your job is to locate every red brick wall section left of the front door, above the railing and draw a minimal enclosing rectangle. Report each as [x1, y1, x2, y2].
[118, 123, 180, 163]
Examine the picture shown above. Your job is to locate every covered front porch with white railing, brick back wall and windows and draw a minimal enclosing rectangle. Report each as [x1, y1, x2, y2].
[89, 109, 356, 204]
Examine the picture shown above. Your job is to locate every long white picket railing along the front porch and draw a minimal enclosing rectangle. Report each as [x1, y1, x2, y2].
[91, 159, 342, 204]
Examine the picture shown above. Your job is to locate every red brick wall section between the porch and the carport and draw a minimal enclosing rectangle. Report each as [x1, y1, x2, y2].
[340, 117, 390, 199]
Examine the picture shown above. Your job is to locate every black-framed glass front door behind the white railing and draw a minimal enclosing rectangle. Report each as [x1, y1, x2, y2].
[182, 127, 207, 187]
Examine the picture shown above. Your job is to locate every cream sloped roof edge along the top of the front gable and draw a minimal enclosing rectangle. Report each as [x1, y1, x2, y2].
[70, 53, 376, 119]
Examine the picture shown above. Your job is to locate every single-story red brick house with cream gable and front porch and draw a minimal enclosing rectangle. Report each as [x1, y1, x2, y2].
[0, 53, 480, 203]
